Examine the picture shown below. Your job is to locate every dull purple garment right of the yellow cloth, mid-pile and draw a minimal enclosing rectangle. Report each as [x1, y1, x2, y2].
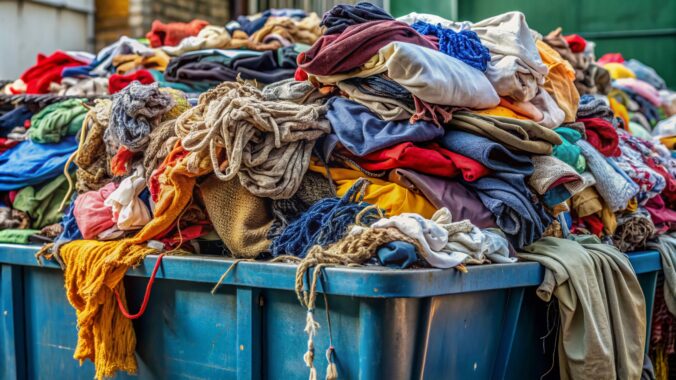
[389, 169, 497, 228]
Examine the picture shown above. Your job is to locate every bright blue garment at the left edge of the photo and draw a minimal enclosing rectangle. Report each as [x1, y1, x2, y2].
[0, 136, 77, 191]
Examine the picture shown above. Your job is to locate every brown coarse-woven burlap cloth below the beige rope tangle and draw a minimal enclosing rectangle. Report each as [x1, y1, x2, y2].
[200, 175, 272, 258]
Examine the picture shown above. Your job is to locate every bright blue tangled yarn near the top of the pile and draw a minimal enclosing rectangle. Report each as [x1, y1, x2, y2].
[411, 21, 491, 71]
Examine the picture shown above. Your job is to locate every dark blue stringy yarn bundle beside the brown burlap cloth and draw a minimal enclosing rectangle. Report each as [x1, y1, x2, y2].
[271, 180, 379, 258]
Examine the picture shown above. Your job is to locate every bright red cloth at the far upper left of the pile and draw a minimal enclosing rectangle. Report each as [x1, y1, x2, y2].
[20, 50, 87, 94]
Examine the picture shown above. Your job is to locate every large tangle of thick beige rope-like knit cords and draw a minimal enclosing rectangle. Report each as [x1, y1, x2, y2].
[176, 82, 331, 199]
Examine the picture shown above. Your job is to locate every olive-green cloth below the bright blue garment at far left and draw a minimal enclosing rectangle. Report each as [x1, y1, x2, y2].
[12, 174, 68, 229]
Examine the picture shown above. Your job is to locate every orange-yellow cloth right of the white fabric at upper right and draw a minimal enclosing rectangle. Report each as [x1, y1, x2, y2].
[536, 40, 580, 123]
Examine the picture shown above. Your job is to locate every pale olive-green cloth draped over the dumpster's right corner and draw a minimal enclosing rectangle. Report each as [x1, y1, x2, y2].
[518, 236, 646, 380]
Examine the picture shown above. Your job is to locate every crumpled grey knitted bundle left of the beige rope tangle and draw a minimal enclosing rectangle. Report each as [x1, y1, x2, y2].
[106, 82, 174, 152]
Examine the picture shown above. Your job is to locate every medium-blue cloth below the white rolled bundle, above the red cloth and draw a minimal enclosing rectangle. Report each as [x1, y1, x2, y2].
[326, 97, 444, 156]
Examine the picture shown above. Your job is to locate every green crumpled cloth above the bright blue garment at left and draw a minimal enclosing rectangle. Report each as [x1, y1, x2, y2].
[28, 99, 87, 144]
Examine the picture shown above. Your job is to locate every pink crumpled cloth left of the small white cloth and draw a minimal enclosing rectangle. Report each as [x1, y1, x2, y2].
[73, 182, 117, 240]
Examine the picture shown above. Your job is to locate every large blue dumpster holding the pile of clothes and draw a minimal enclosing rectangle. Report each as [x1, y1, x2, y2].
[0, 245, 660, 380]
